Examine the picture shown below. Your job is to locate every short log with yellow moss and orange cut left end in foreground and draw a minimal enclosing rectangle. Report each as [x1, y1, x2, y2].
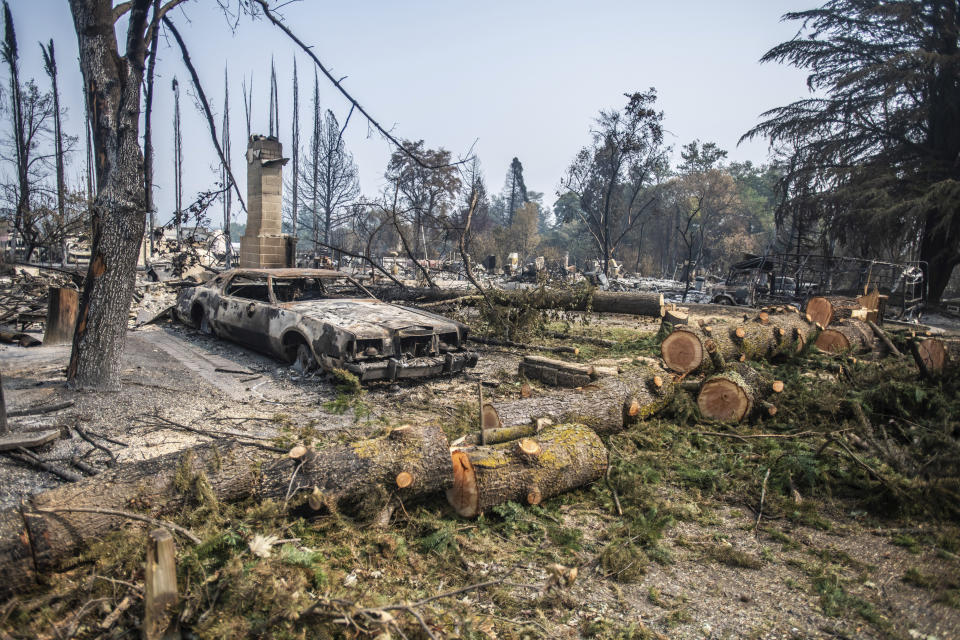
[447, 424, 607, 518]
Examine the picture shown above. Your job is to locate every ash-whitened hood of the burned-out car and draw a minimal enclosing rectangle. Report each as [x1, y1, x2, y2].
[280, 299, 462, 339]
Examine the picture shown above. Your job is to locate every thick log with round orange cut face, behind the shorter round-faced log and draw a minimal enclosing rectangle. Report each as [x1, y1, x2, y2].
[660, 312, 819, 373]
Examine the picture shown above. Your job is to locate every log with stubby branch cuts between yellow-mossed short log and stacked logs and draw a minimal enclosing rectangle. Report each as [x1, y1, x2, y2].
[493, 367, 676, 434]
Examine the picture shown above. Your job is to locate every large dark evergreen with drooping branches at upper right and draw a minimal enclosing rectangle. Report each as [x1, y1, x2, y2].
[744, 0, 960, 301]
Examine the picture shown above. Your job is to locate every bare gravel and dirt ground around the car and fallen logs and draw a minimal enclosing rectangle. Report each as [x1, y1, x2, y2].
[0, 316, 960, 640]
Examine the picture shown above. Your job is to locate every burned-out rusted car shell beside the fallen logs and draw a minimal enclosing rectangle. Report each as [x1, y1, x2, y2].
[176, 269, 477, 382]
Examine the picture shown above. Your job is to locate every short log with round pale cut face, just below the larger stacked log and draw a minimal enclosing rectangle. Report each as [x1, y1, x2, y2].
[697, 363, 784, 422]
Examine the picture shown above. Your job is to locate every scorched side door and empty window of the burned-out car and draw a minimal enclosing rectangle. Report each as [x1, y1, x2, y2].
[217, 273, 276, 351]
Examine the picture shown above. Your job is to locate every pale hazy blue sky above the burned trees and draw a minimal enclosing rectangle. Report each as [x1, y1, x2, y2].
[13, 0, 816, 229]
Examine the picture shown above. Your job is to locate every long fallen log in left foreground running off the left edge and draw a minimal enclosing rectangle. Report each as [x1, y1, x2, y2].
[0, 426, 453, 593]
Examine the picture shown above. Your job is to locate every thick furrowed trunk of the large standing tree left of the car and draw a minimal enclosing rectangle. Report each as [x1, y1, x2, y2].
[67, 0, 150, 389]
